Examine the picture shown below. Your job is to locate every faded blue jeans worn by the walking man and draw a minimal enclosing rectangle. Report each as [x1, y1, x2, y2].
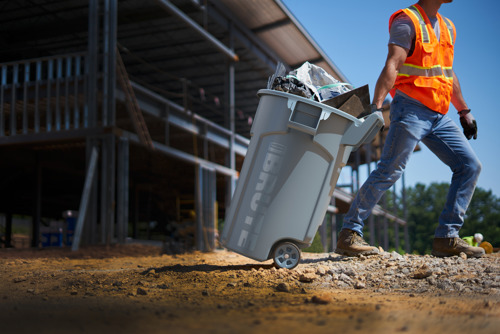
[342, 95, 481, 238]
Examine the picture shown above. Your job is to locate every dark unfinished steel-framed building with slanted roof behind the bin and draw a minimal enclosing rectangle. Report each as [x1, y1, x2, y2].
[0, 0, 409, 251]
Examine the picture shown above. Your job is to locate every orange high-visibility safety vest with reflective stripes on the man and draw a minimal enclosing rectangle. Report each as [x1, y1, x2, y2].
[389, 4, 456, 114]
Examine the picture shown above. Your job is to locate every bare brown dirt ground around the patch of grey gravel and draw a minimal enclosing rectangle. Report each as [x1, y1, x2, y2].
[0, 244, 500, 334]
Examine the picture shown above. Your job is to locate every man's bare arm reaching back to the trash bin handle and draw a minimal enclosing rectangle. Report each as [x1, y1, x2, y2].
[373, 44, 408, 109]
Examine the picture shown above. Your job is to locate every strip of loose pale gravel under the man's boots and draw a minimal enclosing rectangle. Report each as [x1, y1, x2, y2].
[296, 252, 500, 295]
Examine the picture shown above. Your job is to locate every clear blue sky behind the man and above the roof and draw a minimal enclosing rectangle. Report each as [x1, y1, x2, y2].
[282, 0, 500, 197]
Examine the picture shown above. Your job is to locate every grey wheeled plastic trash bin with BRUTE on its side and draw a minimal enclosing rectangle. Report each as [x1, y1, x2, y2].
[221, 89, 384, 269]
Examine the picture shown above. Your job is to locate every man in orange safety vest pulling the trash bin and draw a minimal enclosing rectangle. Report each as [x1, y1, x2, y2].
[336, 0, 484, 257]
